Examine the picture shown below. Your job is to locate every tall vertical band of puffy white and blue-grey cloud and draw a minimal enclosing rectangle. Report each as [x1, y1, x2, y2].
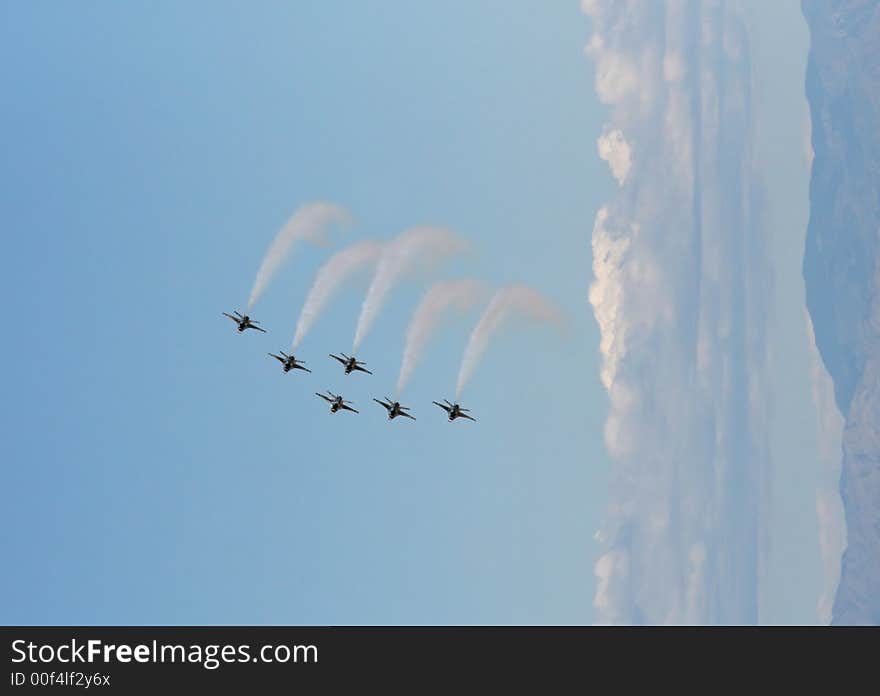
[582, 0, 771, 624]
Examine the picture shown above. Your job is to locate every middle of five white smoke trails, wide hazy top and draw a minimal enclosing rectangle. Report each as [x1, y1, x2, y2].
[353, 226, 468, 352]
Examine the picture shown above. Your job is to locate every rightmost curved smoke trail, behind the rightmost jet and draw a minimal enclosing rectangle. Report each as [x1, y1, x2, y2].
[455, 285, 562, 398]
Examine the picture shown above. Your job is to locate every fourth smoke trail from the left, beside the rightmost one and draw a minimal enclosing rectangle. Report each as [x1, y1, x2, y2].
[397, 280, 484, 394]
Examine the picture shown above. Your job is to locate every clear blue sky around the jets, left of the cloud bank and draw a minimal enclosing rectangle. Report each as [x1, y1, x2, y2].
[0, 2, 613, 624]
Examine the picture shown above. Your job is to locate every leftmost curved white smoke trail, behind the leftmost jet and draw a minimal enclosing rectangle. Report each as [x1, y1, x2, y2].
[248, 202, 351, 309]
